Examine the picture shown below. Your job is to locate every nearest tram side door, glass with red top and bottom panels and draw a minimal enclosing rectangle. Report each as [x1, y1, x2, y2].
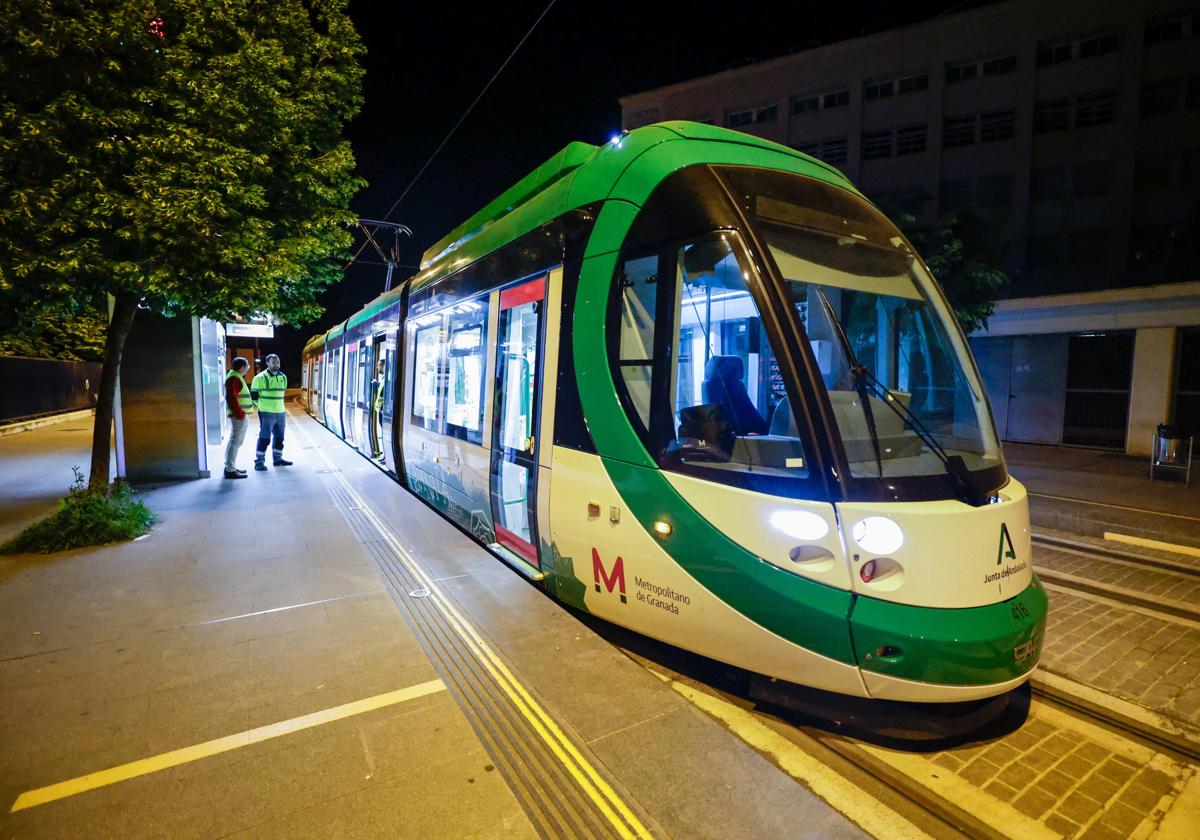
[491, 276, 546, 568]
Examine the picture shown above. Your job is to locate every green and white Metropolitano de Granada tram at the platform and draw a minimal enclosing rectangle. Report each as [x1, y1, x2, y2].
[304, 122, 1046, 702]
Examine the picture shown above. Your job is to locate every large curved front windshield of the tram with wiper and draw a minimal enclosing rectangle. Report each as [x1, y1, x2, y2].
[721, 168, 1002, 479]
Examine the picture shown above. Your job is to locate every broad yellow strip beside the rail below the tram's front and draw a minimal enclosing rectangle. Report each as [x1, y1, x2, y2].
[650, 668, 930, 840]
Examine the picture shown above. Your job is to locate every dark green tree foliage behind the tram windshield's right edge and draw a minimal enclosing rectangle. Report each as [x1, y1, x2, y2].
[894, 214, 1009, 335]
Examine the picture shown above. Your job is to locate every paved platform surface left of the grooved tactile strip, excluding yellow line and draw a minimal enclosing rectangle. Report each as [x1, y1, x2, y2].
[0, 427, 534, 838]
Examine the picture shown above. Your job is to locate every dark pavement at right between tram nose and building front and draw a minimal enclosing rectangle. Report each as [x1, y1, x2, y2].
[1004, 443, 1200, 551]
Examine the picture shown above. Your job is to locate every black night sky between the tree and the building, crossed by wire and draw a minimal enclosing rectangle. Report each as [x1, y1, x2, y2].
[272, 0, 982, 376]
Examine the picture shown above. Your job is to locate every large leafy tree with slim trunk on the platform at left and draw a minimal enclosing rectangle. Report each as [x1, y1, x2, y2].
[0, 0, 362, 487]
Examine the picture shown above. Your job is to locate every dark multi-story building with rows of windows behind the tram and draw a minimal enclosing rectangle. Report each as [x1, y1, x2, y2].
[620, 0, 1200, 454]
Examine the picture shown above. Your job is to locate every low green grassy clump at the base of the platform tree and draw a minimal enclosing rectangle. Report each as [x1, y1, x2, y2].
[0, 467, 156, 554]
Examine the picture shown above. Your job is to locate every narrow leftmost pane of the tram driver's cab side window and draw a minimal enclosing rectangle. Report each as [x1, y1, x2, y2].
[617, 254, 659, 430]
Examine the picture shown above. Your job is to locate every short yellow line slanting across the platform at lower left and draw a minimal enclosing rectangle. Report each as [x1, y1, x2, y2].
[8, 679, 446, 814]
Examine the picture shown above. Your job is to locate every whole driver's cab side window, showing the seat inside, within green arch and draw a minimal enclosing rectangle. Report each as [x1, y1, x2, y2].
[611, 232, 809, 484]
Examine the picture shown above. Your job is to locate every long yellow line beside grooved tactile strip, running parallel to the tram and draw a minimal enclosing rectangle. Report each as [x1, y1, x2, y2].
[296, 424, 652, 838]
